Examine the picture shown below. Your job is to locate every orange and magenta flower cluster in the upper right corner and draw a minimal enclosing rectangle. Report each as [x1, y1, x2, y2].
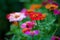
[42, 2, 60, 15]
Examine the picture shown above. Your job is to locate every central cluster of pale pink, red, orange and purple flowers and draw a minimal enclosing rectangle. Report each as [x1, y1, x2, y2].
[7, 5, 46, 35]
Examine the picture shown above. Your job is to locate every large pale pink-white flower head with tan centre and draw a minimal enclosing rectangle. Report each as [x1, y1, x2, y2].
[7, 12, 26, 22]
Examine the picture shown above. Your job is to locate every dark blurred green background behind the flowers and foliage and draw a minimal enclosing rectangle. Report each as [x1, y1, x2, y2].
[0, 0, 60, 38]
